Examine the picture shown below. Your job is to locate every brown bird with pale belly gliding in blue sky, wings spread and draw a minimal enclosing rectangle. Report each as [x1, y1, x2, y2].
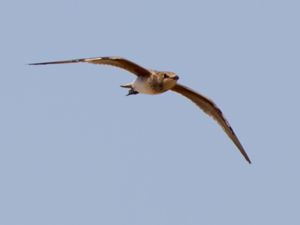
[29, 57, 251, 164]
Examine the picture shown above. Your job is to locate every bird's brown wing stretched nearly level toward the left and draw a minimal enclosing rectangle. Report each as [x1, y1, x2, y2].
[29, 57, 151, 77]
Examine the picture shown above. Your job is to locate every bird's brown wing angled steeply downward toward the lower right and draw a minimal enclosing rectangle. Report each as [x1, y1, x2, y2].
[171, 84, 251, 163]
